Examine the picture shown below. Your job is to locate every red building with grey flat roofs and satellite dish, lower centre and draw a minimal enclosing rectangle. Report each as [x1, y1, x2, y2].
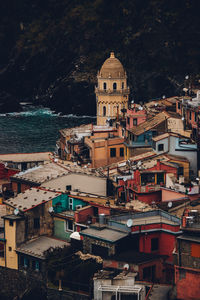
[80, 210, 180, 283]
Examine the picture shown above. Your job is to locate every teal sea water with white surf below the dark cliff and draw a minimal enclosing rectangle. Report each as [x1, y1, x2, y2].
[0, 105, 96, 154]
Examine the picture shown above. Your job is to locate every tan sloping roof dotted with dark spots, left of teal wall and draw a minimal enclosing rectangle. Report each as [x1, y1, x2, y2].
[4, 188, 60, 211]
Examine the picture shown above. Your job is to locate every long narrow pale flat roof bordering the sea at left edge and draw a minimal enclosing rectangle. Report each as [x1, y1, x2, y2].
[0, 152, 52, 163]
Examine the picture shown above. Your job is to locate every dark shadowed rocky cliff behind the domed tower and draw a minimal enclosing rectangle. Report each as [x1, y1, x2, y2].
[0, 0, 200, 114]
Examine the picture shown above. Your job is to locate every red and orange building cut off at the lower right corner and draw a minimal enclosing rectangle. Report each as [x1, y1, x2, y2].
[174, 209, 200, 300]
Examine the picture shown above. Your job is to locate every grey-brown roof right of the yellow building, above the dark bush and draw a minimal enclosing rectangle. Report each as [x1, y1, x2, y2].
[16, 236, 70, 259]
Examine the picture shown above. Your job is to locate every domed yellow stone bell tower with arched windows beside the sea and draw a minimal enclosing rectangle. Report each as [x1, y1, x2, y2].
[95, 52, 129, 125]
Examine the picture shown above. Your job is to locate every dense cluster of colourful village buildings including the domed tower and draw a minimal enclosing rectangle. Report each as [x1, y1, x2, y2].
[0, 53, 200, 299]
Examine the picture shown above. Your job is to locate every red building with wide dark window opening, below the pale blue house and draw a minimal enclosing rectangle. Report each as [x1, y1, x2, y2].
[118, 160, 178, 204]
